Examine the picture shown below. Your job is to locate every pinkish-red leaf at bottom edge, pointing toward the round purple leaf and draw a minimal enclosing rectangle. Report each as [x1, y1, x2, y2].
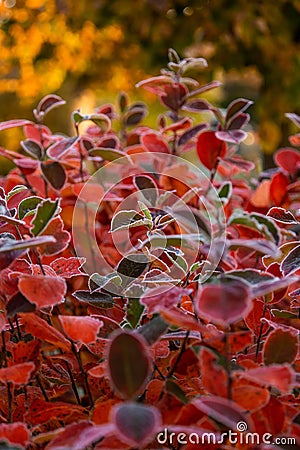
[46, 421, 114, 450]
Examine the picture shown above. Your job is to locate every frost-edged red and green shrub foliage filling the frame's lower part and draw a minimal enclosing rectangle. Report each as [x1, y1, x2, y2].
[0, 49, 300, 450]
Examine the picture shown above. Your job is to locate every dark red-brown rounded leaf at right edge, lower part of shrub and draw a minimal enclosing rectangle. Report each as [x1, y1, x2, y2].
[263, 328, 299, 366]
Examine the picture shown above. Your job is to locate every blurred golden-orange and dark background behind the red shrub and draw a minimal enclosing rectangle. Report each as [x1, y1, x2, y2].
[0, 0, 300, 171]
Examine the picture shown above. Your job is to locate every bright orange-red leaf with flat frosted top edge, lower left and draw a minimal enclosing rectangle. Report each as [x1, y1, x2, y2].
[59, 316, 103, 344]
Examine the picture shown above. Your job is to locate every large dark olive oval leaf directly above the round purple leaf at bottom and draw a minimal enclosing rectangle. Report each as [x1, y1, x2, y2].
[107, 330, 152, 399]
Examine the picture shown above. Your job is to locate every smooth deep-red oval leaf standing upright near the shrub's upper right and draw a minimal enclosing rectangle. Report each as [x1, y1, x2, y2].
[197, 131, 226, 170]
